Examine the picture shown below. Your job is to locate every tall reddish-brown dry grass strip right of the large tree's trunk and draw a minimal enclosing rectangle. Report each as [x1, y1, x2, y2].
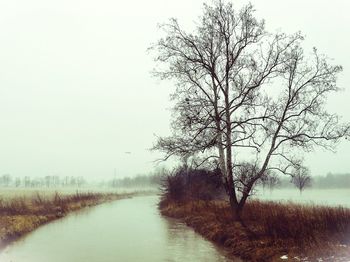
[244, 201, 350, 245]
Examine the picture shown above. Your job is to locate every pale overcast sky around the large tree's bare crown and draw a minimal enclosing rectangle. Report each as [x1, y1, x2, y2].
[0, 0, 350, 178]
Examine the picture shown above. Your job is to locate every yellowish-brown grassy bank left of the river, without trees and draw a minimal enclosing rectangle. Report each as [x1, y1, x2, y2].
[0, 190, 132, 248]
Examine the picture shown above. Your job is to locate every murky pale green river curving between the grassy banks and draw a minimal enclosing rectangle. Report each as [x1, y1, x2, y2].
[0, 196, 238, 262]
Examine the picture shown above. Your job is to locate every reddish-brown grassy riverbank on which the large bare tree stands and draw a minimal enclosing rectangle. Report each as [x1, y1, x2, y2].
[160, 200, 350, 261]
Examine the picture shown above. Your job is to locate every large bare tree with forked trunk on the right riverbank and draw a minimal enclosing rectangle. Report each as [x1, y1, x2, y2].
[153, 1, 349, 219]
